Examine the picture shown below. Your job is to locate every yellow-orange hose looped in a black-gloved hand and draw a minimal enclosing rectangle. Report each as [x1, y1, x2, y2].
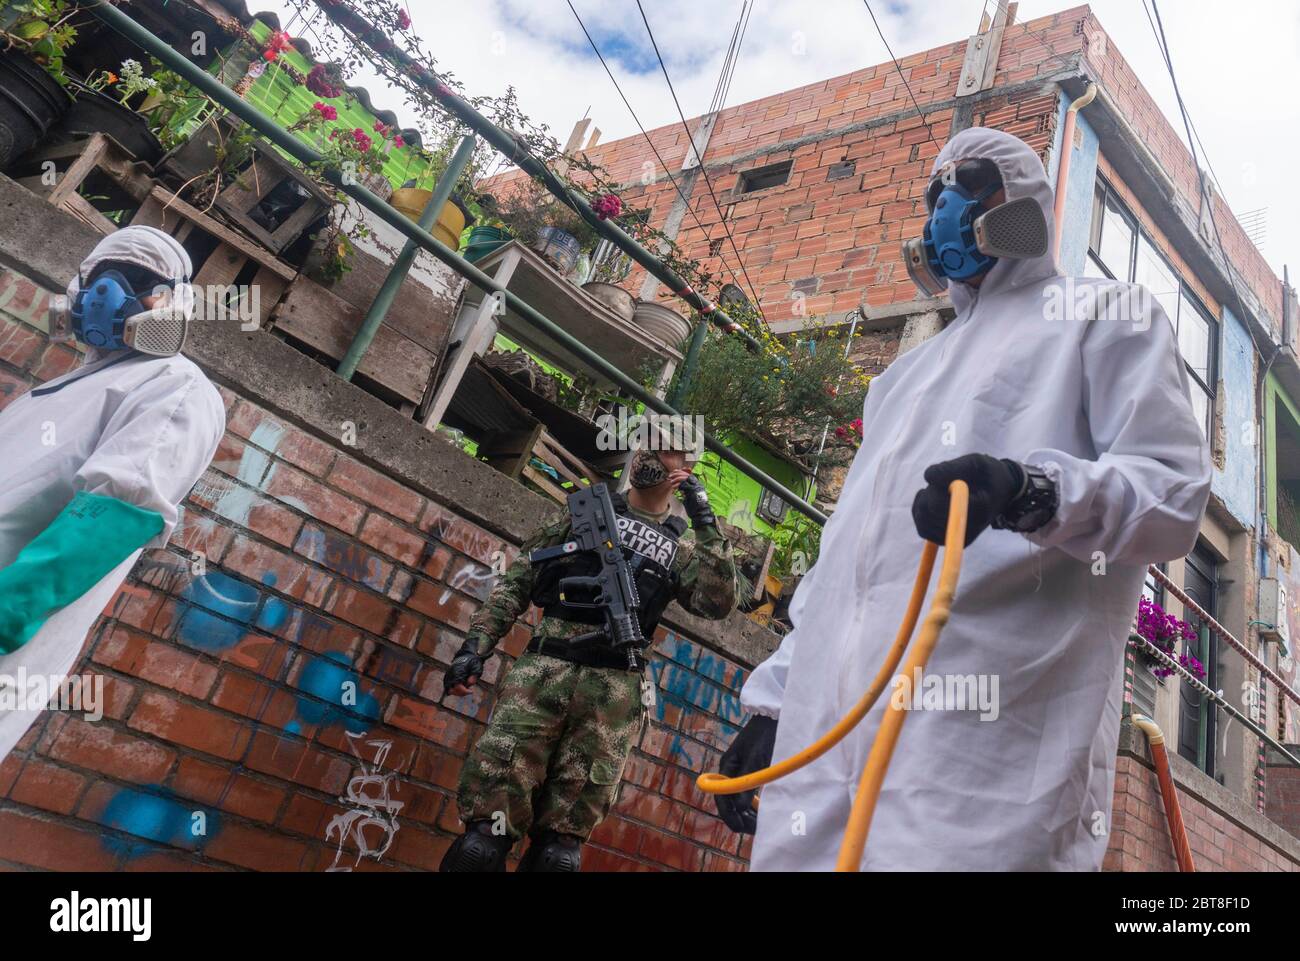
[696, 480, 970, 871]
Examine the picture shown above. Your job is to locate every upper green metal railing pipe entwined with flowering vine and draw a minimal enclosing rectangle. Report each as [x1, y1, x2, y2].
[301, 0, 763, 352]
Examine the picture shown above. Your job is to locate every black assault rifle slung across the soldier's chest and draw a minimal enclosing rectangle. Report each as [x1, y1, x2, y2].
[528, 484, 645, 670]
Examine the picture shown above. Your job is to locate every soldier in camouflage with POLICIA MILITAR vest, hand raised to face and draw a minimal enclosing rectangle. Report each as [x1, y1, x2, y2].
[441, 436, 736, 871]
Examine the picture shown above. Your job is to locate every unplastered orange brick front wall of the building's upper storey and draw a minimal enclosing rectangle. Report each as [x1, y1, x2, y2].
[485, 8, 1088, 329]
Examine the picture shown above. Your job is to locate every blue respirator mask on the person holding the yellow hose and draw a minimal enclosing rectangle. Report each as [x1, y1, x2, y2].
[902, 161, 1048, 296]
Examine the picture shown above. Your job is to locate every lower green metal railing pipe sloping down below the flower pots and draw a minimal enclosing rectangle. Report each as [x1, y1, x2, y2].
[87, 0, 827, 524]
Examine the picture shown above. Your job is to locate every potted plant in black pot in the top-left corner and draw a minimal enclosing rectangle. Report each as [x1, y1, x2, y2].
[0, 0, 77, 168]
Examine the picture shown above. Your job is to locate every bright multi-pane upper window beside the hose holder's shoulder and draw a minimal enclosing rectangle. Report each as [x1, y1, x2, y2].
[1083, 181, 1218, 437]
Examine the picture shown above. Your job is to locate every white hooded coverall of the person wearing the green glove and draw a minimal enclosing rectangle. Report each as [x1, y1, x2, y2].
[0, 228, 225, 759]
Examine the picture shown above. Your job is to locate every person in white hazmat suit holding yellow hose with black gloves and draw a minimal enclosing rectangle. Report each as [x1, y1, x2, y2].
[719, 129, 1210, 871]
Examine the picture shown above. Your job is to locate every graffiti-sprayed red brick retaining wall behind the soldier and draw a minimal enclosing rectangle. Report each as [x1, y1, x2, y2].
[0, 261, 746, 871]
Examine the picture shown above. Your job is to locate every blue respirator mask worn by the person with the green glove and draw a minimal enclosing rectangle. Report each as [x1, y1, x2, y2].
[61, 268, 189, 356]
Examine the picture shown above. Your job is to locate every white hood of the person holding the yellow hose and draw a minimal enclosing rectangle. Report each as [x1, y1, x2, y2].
[931, 127, 1061, 312]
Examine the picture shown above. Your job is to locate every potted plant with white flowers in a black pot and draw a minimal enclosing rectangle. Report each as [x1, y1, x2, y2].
[53, 60, 163, 164]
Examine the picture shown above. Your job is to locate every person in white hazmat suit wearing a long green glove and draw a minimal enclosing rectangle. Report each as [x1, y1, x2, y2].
[0, 226, 225, 759]
